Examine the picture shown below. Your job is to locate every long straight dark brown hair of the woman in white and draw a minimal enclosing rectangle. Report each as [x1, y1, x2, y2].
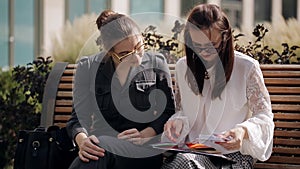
[184, 4, 234, 98]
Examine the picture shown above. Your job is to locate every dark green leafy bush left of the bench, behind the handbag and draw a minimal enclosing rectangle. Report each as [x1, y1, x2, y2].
[0, 57, 52, 168]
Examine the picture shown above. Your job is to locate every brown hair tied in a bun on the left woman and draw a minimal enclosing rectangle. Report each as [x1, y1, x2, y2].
[96, 10, 141, 51]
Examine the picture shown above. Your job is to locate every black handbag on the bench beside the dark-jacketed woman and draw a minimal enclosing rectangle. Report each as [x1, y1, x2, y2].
[14, 126, 78, 169]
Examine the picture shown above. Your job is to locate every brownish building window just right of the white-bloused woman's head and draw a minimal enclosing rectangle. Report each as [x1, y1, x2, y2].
[221, 0, 243, 28]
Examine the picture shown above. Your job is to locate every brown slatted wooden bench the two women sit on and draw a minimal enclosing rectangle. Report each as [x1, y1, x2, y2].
[41, 63, 300, 169]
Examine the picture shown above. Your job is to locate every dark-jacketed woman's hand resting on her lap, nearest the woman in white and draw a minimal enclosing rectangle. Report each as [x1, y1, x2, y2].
[118, 128, 144, 145]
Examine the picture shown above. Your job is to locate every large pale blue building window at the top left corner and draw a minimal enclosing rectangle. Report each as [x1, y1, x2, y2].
[0, 0, 35, 67]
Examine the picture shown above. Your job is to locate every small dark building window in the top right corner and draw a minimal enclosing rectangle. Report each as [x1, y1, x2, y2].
[282, 0, 300, 19]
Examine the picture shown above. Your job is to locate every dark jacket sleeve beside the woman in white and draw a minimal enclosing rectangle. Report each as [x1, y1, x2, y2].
[149, 56, 175, 134]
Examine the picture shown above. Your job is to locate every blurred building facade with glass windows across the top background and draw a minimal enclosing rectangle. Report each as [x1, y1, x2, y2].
[0, 0, 300, 68]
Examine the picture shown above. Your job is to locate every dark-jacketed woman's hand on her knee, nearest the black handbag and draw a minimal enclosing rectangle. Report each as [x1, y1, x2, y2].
[75, 133, 105, 162]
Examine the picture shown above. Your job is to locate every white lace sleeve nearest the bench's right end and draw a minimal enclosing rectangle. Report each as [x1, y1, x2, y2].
[237, 63, 274, 161]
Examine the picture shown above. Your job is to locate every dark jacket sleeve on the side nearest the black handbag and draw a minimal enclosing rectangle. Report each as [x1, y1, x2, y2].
[67, 57, 92, 139]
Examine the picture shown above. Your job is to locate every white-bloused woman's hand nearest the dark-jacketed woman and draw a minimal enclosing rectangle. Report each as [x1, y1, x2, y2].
[164, 119, 183, 142]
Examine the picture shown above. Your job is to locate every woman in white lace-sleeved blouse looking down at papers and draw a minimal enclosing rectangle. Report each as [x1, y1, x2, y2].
[162, 4, 274, 168]
